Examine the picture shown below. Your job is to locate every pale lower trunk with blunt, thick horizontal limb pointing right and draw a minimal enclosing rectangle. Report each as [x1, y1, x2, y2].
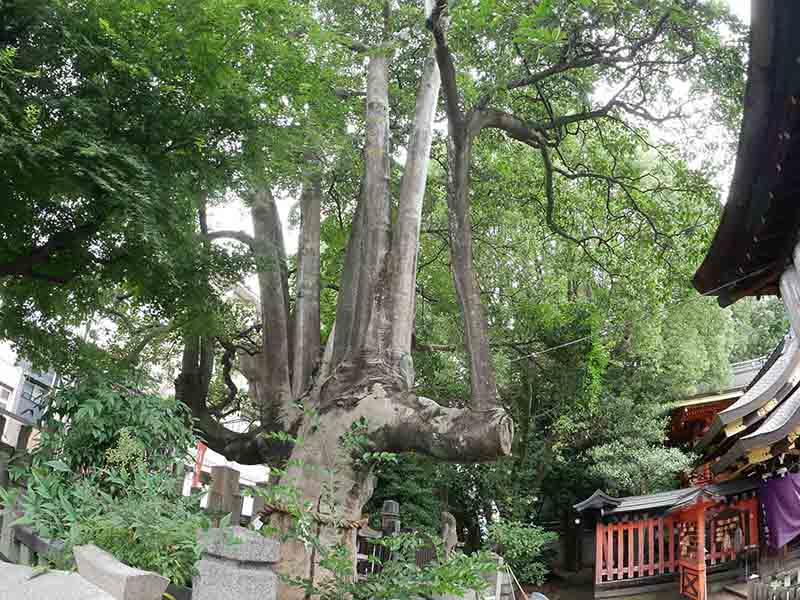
[273, 382, 514, 600]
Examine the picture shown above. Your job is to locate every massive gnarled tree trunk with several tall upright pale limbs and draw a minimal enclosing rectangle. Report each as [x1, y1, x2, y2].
[176, 22, 513, 599]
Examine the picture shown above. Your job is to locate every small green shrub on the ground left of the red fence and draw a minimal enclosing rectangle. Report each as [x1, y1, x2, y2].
[489, 521, 558, 584]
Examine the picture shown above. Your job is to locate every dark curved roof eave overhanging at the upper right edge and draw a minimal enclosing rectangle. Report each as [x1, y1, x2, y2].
[693, 2, 800, 306]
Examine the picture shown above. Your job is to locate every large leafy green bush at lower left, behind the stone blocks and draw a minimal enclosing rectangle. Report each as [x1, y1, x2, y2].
[10, 377, 210, 585]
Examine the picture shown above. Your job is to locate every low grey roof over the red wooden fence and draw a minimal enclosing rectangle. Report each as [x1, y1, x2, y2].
[574, 479, 759, 516]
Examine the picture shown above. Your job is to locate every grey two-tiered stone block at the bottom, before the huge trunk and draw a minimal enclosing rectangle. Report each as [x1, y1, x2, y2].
[192, 526, 280, 600]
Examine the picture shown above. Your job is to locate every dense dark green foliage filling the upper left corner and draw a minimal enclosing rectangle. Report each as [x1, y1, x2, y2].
[0, 0, 340, 373]
